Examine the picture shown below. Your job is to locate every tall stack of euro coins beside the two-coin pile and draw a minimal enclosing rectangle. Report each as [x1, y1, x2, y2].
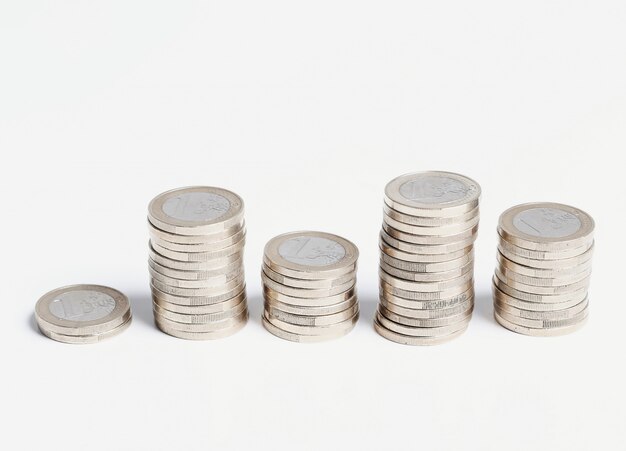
[148, 186, 248, 340]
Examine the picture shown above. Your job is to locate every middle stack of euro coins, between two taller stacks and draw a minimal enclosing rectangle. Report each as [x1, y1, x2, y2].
[261, 232, 359, 343]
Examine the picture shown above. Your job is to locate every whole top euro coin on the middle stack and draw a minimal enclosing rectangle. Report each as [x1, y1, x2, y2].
[264, 231, 359, 279]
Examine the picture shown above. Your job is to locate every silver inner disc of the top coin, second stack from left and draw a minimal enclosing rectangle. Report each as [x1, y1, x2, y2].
[162, 192, 230, 222]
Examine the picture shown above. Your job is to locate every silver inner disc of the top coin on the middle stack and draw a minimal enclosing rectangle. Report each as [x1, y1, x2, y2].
[278, 236, 346, 266]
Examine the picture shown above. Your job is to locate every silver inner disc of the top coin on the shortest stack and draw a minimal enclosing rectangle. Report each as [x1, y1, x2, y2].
[48, 290, 115, 321]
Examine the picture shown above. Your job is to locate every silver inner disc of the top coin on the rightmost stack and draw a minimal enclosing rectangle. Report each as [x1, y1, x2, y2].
[513, 208, 582, 238]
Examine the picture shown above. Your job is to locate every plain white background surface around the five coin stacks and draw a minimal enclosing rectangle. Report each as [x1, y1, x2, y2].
[0, 0, 626, 451]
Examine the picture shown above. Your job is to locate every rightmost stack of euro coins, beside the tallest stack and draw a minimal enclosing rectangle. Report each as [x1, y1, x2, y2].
[493, 203, 594, 336]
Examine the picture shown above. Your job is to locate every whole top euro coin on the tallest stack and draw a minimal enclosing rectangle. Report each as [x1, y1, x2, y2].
[385, 171, 480, 218]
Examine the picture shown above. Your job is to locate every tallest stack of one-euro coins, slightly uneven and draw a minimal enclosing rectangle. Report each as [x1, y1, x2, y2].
[374, 171, 480, 345]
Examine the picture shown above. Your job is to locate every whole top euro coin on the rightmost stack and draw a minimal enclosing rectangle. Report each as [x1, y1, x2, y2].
[498, 202, 594, 252]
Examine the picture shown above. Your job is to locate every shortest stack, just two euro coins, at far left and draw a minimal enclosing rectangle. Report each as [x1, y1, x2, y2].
[35, 285, 132, 344]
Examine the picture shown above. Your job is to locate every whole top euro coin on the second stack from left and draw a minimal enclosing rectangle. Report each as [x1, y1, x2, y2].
[148, 186, 243, 235]
